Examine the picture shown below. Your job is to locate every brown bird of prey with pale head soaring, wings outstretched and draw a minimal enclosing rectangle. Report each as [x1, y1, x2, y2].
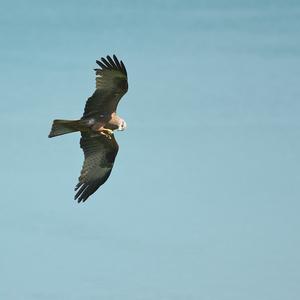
[48, 55, 128, 203]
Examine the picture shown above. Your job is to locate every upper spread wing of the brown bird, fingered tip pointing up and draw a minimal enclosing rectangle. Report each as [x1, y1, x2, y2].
[82, 55, 128, 118]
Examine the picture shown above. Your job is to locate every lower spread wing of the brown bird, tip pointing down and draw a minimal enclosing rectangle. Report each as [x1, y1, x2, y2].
[75, 133, 119, 203]
